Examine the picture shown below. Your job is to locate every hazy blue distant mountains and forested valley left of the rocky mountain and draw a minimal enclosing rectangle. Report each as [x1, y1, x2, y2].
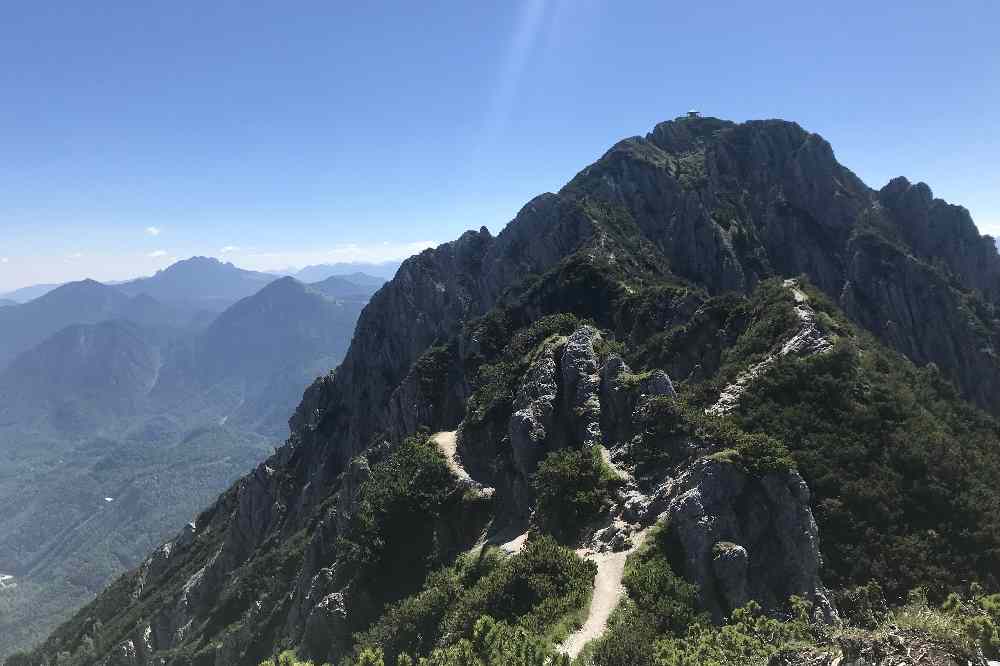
[0, 257, 384, 657]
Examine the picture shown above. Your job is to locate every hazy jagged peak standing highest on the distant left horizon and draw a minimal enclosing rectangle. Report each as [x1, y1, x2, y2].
[117, 257, 275, 309]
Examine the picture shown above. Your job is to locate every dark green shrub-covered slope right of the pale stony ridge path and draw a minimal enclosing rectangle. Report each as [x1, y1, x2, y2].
[734, 337, 1000, 602]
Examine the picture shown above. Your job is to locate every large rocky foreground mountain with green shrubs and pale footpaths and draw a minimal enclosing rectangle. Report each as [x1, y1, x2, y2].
[9, 118, 1000, 666]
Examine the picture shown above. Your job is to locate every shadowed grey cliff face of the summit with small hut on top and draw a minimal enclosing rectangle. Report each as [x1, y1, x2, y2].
[562, 118, 1000, 412]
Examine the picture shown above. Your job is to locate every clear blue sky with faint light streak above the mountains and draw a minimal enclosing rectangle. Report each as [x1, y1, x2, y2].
[0, 0, 1000, 290]
